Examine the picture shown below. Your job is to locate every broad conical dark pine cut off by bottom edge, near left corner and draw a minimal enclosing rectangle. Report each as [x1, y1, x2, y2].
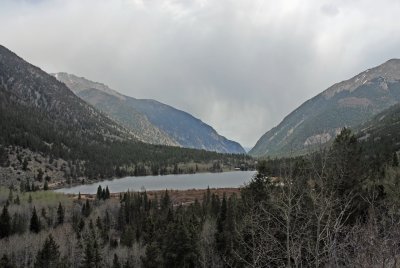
[35, 234, 60, 268]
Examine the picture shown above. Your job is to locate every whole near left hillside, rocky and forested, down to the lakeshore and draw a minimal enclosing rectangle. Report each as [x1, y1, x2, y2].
[0, 46, 249, 187]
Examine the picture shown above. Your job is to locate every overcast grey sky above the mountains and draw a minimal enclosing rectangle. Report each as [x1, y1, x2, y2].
[0, 0, 400, 147]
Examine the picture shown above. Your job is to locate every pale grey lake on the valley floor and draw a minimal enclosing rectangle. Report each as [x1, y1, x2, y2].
[56, 171, 256, 194]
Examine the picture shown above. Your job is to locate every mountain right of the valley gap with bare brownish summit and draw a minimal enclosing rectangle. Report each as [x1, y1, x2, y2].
[249, 59, 400, 157]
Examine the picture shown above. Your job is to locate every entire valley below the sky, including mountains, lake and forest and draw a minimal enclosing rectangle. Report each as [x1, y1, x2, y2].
[0, 40, 400, 268]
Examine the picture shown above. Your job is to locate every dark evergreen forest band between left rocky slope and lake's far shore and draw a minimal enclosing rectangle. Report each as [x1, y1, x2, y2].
[0, 91, 252, 184]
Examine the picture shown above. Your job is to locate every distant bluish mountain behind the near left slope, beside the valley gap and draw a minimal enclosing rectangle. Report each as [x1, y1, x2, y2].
[54, 73, 245, 154]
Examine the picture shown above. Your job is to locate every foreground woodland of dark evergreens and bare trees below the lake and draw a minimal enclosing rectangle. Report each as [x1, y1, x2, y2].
[0, 129, 400, 267]
